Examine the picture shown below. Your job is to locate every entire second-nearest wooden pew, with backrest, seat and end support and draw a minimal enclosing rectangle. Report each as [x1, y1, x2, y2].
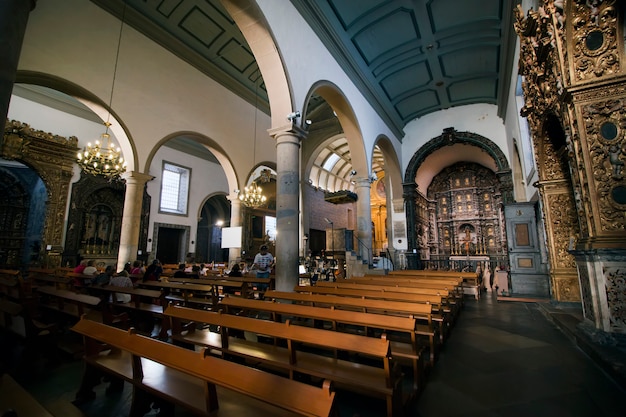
[165, 305, 404, 417]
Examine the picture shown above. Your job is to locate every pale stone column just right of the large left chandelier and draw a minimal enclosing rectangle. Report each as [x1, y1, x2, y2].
[117, 171, 154, 270]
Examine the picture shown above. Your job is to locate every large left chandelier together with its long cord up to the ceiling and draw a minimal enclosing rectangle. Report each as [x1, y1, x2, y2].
[76, 2, 126, 181]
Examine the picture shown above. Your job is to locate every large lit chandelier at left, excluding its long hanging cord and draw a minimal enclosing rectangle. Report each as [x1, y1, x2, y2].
[77, 122, 126, 179]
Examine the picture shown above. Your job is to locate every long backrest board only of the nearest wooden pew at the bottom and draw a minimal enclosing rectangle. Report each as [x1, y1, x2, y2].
[72, 318, 335, 416]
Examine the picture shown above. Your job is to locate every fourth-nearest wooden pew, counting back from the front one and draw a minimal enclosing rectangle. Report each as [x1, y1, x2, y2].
[265, 290, 443, 365]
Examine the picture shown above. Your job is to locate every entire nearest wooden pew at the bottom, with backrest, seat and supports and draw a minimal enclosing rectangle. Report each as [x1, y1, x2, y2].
[72, 319, 335, 417]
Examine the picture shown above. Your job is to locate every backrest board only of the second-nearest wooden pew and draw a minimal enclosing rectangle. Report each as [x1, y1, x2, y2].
[164, 305, 390, 358]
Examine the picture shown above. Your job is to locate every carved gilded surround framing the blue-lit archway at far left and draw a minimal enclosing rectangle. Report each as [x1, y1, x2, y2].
[0, 120, 78, 267]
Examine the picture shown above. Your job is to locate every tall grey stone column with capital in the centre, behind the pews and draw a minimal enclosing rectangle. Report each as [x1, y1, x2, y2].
[269, 125, 305, 291]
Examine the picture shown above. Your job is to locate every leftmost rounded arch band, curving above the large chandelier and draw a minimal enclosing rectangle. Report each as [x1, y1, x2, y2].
[15, 70, 139, 171]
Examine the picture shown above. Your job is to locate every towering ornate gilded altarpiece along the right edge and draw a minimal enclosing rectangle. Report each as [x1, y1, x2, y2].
[516, 0, 626, 333]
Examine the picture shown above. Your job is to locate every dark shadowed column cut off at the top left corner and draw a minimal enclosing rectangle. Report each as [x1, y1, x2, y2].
[0, 0, 37, 135]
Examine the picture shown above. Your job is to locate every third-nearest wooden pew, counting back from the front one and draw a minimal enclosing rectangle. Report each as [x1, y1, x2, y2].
[219, 296, 424, 393]
